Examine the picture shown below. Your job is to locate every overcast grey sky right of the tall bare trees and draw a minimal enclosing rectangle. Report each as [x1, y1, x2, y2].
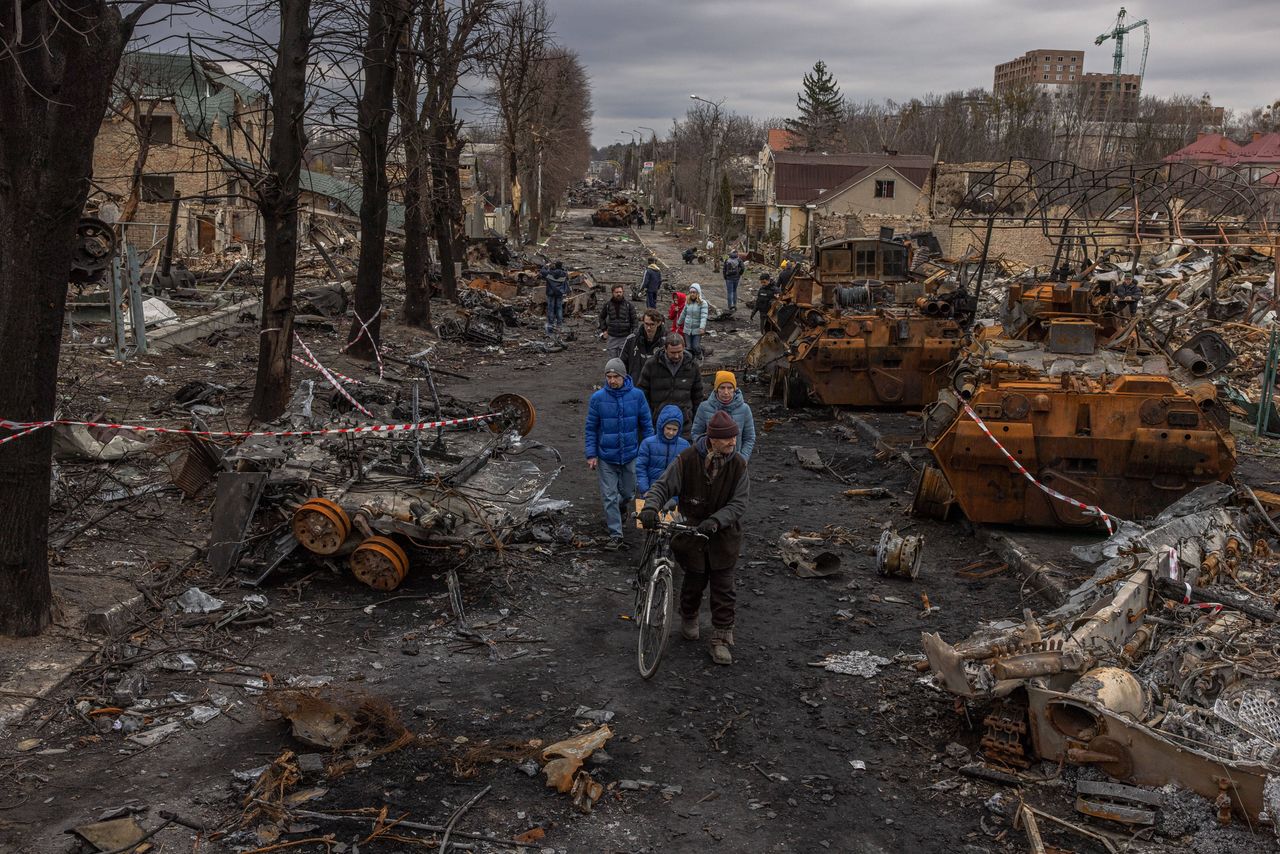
[549, 0, 1280, 146]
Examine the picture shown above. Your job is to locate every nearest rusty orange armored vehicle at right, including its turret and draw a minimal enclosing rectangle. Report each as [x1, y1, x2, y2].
[914, 277, 1235, 528]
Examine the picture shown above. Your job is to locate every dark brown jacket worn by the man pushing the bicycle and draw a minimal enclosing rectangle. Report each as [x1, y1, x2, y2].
[644, 437, 750, 572]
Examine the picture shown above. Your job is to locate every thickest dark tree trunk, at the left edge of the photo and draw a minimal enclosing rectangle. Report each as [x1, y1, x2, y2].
[0, 0, 136, 635]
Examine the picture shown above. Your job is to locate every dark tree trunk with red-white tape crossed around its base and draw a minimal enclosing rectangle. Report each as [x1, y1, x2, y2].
[347, 0, 408, 359]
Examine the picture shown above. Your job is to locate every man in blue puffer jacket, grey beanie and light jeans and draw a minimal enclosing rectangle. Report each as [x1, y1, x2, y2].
[585, 359, 653, 549]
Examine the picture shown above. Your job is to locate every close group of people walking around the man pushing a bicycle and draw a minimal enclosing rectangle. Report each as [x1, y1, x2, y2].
[584, 286, 755, 665]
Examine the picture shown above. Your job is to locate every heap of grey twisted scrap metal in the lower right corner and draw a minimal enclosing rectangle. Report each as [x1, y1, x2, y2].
[923, 484, 1280, 828]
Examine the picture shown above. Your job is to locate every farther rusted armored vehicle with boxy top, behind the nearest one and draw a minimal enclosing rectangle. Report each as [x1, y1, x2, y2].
[748, 236, 975, 408]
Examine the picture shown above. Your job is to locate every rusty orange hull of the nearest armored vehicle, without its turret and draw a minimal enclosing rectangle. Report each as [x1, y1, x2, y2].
[915, 341, 1235, 528]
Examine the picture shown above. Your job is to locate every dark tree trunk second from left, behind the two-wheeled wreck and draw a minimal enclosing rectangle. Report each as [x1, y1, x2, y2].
[248, 0, 311, 421]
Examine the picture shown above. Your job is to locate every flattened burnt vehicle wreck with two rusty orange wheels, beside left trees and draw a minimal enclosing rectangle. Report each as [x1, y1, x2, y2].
[209, 389, 561, 592]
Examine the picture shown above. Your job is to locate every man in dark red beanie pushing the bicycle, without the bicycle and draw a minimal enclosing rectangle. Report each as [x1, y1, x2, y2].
[640, 412, 750, 665]
